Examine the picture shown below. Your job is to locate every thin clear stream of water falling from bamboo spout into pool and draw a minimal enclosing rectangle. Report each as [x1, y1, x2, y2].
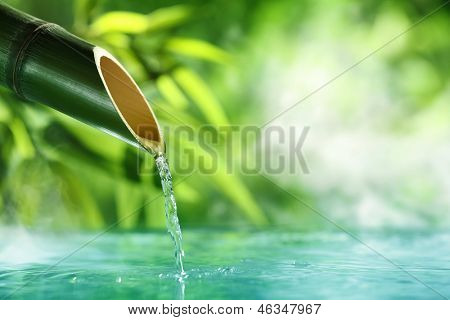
[156, 154, 186, 276]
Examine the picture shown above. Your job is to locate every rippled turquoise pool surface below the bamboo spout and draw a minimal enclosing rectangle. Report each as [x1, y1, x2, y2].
[0, 229, 450, 299]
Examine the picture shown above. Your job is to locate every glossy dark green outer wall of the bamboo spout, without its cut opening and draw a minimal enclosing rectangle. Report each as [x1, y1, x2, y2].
[0, 3, 138, 146]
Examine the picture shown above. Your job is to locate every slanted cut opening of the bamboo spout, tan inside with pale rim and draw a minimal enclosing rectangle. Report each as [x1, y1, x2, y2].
[94, 48, 164, 153]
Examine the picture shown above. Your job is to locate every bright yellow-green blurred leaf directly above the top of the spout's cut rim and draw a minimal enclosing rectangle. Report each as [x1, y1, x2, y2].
[90, 11, 149, 36]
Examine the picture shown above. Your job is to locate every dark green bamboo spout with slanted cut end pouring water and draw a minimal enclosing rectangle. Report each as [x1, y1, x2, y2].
[0, 3, 165, 155]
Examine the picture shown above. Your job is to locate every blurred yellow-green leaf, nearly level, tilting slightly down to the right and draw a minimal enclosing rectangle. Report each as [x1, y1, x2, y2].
[165, 38, 233, 64]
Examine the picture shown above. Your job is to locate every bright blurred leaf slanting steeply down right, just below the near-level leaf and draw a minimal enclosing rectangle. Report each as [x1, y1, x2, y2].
[174, 68, 229, 126]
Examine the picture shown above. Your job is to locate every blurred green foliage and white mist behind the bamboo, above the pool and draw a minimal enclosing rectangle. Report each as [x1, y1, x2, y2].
[0, 0, 450, 229]
